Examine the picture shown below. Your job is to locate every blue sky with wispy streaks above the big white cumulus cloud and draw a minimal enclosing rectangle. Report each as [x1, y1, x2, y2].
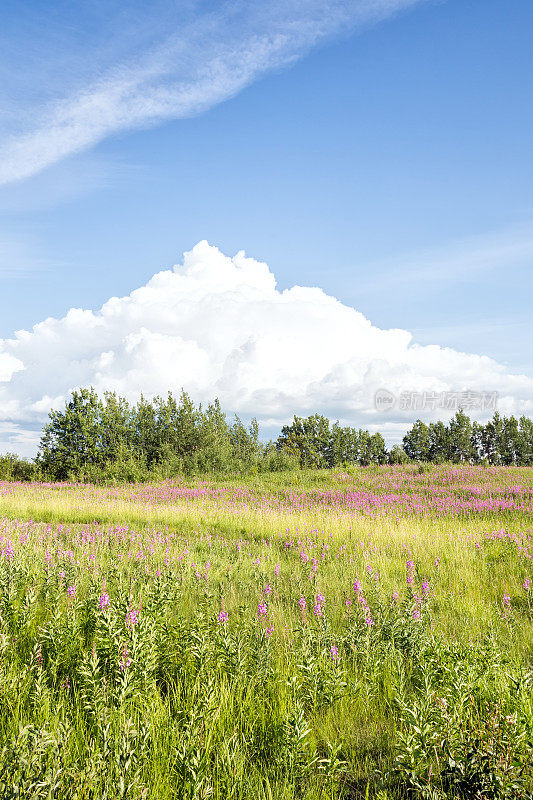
[0, 0, 533, 450]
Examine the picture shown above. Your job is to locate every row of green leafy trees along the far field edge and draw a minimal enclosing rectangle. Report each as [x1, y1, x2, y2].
[0, 388, 533, 482]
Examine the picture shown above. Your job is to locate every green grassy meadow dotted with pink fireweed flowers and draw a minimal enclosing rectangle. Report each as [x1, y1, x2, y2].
[0, 467, 533, 800]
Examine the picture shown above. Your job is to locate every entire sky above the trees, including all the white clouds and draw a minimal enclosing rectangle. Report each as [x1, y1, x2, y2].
[0, 0, 533, 456]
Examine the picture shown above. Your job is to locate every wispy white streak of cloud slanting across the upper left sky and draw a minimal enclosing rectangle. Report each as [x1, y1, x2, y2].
[0, 0, 422, 184]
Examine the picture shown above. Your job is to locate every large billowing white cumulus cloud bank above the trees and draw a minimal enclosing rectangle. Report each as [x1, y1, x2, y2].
[0, 241, 533, 453]
